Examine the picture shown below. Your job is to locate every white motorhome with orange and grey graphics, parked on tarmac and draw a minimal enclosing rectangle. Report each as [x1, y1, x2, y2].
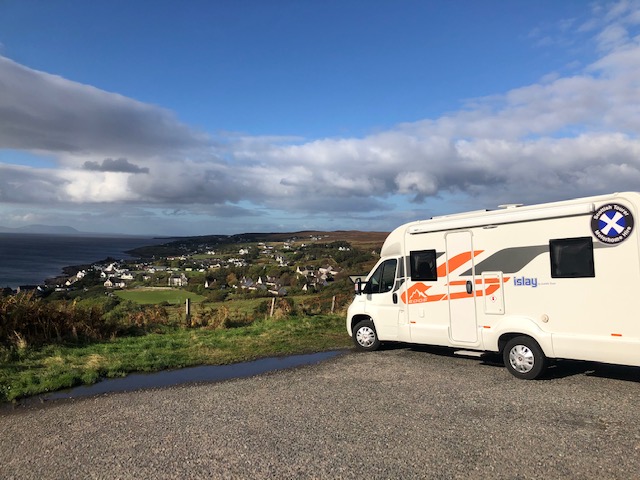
[347, 192, 640, 379]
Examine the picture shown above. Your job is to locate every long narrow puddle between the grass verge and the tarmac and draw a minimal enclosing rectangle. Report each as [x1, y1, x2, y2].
[19, 350, 348, 405]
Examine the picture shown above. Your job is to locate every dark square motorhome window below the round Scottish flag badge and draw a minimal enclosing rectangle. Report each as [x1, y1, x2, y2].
[549, 237, 596, 278]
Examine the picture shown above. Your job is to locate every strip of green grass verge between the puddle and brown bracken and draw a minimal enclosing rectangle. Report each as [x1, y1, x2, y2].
[0, 315, 351, 401]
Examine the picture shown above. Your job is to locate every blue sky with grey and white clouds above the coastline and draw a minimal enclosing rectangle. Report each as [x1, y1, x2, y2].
[0, 0, 640, 236]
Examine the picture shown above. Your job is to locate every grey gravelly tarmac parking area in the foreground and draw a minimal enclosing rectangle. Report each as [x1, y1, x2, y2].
[0, 346, 640, 479]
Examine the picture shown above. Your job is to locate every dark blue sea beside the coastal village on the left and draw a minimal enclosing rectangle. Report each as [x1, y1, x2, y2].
[0, 233, 171, 289]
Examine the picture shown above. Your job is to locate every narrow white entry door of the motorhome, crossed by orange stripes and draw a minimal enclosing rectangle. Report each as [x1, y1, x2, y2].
[446, 232, 478, 343]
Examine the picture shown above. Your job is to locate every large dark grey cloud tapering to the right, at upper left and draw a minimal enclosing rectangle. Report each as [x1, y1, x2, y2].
[0, 55, 209, 155]
